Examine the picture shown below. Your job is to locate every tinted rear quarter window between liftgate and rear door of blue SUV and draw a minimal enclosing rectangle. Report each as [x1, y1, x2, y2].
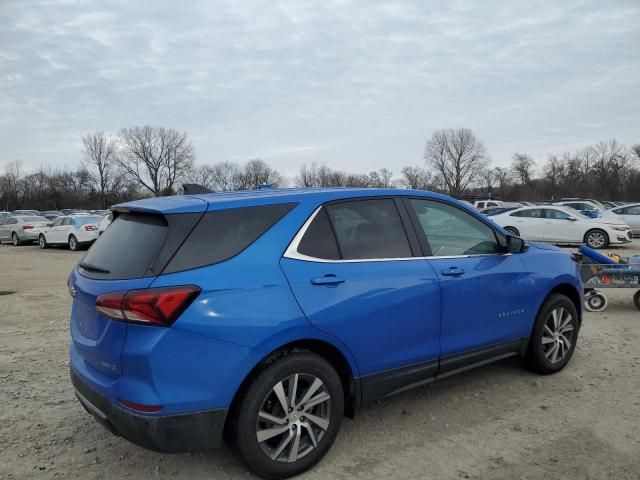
[164, 203, 296, 273]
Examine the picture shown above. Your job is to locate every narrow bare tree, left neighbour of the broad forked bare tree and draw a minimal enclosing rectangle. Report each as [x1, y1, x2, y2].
[82, 132, 118, 208]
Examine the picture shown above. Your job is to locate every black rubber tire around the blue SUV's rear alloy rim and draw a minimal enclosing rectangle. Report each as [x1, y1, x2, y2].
[227, 351, 344, 479]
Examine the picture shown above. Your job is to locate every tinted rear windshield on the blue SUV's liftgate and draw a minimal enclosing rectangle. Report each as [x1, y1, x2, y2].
[79, 213, 168, 279]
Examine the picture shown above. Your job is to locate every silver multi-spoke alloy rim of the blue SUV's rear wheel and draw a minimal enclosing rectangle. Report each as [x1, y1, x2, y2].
[256, 373, 331, 463]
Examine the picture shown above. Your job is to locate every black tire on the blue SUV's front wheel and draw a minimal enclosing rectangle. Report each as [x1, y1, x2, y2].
[525, 293, 580, 375]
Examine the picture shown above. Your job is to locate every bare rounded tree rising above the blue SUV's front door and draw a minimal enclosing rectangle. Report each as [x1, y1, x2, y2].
[424, 128, 489, 196]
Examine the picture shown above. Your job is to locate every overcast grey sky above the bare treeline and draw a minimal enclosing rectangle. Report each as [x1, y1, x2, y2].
[0, 0, 640, 179]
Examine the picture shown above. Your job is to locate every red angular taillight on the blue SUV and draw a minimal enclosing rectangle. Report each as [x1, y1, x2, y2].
[96, 285, 201, 327]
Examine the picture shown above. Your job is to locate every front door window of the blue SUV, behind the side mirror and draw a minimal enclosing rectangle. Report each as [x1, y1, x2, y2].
[410, 199, 499, 256]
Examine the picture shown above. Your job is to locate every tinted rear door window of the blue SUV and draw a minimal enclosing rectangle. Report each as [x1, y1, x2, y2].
[327, 199, 412, 260]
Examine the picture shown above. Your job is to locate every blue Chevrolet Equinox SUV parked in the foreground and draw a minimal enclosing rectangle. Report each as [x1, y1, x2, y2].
[68, 188, 583, 478]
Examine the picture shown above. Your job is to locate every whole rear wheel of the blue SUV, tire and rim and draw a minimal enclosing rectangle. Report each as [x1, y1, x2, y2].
[229, 351, 344, 479]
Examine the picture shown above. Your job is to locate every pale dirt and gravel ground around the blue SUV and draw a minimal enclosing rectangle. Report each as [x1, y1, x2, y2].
[0, 240, 640, 480]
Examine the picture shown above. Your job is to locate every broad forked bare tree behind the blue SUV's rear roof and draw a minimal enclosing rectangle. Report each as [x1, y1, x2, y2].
[118, 126, 194, 197]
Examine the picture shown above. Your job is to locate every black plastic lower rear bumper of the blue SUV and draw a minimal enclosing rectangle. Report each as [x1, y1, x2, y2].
[71, 368, 227, 453]
